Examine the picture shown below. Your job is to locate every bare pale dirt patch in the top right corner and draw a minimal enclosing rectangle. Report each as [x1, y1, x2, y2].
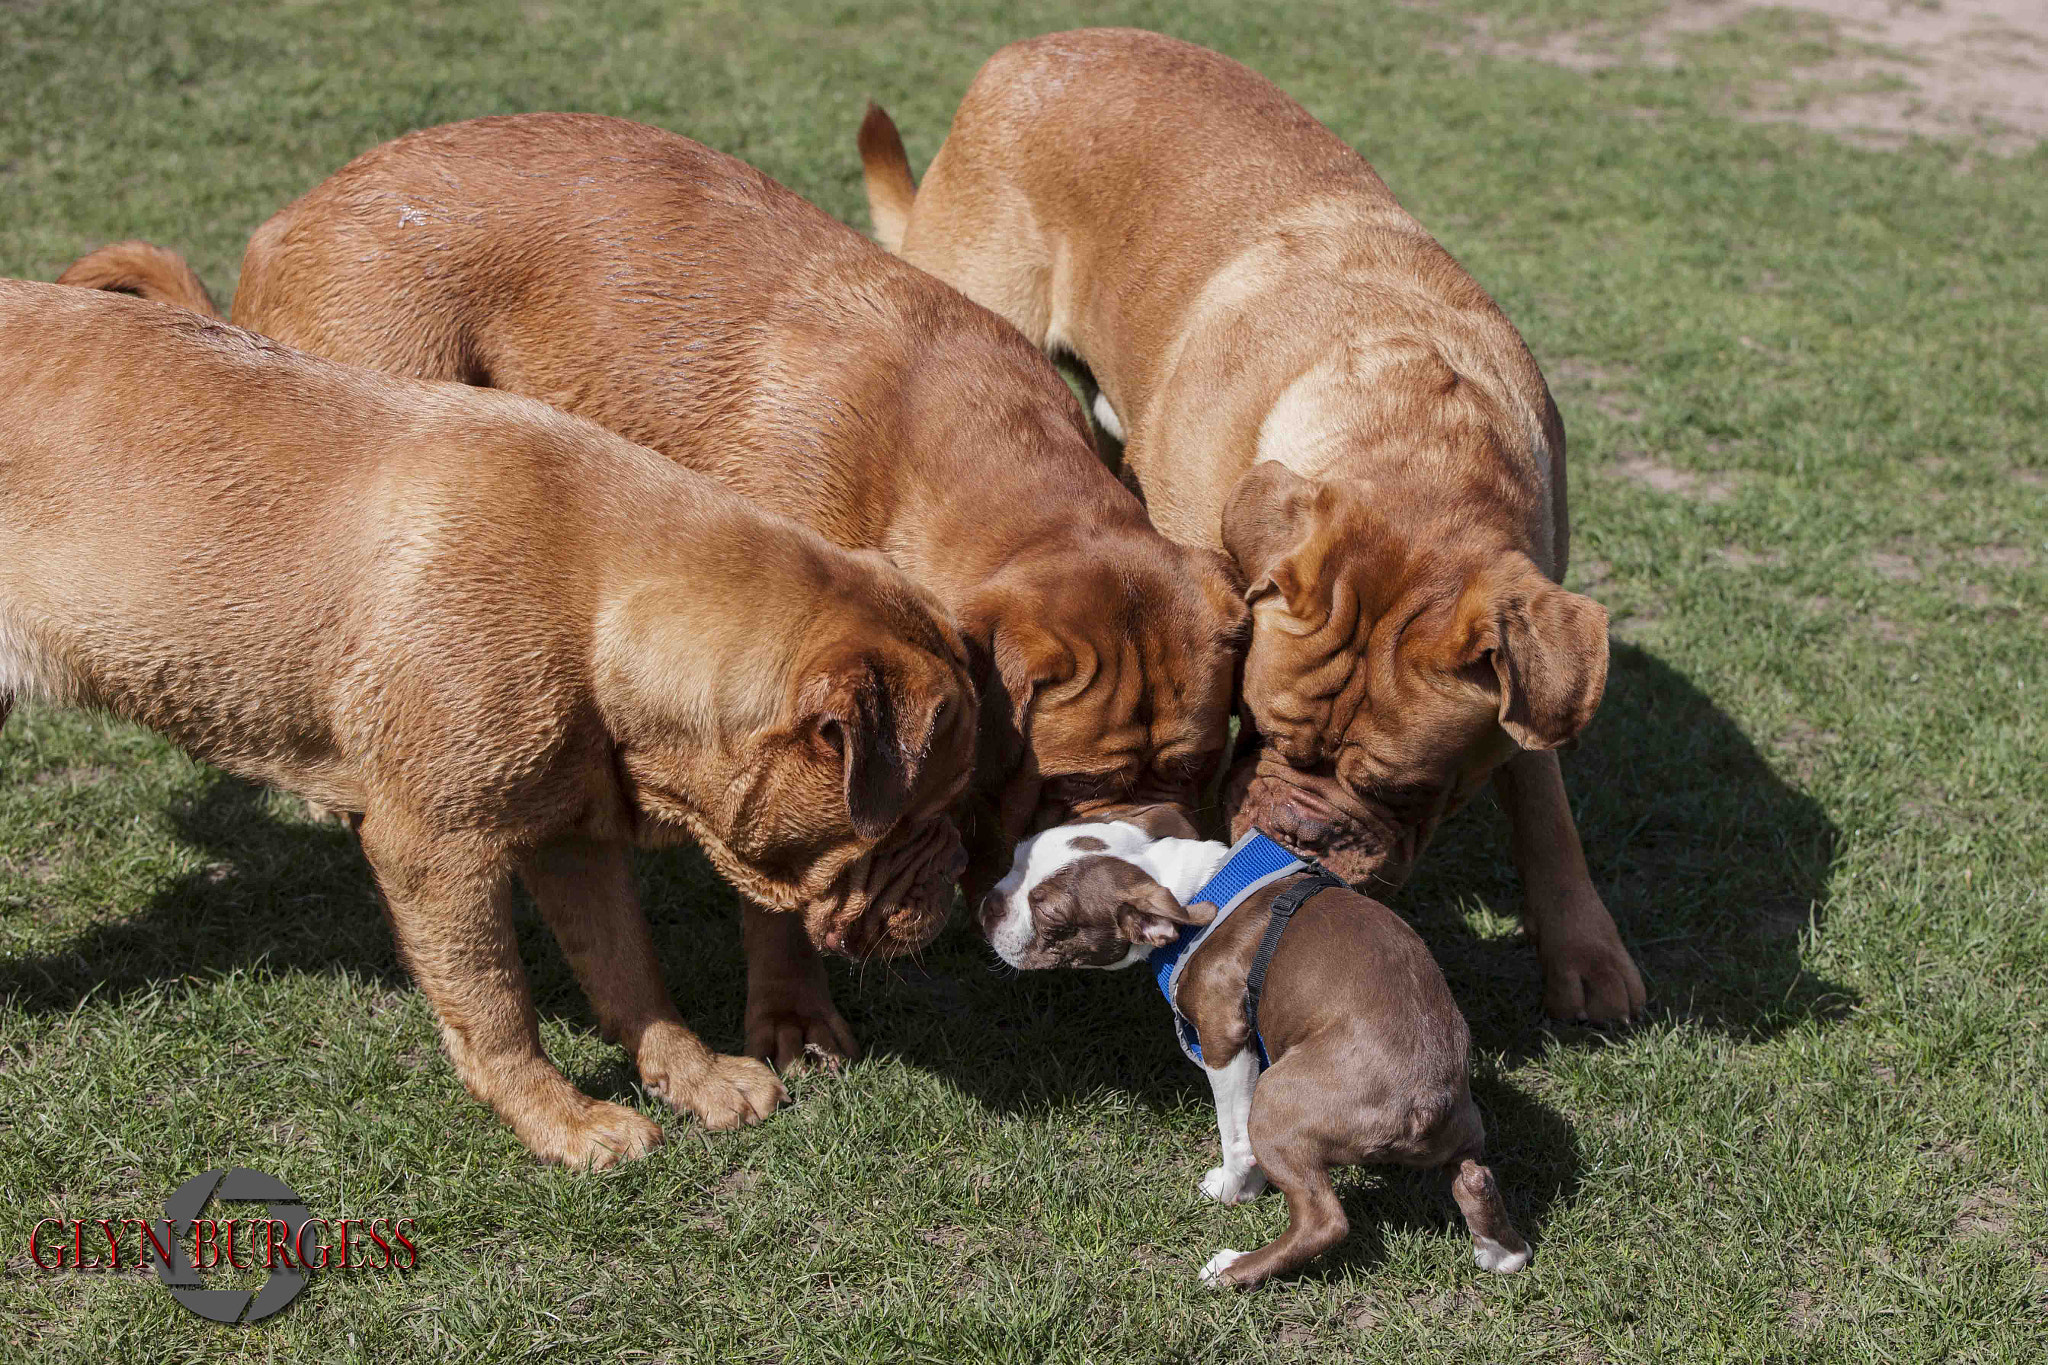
[1464, 0, 2048, 153]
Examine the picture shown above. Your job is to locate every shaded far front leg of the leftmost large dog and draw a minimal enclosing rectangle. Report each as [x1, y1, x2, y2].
[520, 837, 788, 1128]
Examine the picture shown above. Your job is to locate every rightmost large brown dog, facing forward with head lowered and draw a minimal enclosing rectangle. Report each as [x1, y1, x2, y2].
[860, 29, 1642, 1019]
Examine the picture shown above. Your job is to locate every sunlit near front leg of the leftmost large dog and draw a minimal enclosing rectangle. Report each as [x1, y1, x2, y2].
[358, 810, 662, 1169]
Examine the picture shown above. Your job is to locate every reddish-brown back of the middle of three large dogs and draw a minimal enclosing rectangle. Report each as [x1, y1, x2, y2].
[233, 115, 1120, 548]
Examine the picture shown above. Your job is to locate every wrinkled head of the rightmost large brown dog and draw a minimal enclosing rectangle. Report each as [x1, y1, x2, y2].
[1223, 463, 1608, 892]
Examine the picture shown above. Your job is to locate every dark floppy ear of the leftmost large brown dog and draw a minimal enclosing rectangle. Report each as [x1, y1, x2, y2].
[797, 655, 933, 839]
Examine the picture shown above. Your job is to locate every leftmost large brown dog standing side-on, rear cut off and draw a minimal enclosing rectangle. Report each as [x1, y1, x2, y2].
[0, 280, 975, 1166]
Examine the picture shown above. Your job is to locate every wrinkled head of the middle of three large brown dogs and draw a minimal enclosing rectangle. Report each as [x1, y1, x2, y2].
[965, 536, 1251, 902]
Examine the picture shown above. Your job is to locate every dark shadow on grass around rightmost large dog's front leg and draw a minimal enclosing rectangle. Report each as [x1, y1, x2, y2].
[1395, 643, 1855, 1062]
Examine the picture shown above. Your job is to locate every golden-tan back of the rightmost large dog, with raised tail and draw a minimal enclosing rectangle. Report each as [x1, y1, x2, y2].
[862, 29, 1563, 544]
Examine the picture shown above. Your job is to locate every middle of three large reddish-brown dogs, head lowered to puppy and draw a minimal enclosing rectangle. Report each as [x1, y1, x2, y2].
[66, 115, 1249, 994]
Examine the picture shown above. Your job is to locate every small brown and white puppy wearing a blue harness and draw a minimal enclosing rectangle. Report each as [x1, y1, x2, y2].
[981, 821, 1530, 1287]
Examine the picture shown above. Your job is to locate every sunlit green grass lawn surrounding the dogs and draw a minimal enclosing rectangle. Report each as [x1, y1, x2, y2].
[0, 0, 2048, 1363]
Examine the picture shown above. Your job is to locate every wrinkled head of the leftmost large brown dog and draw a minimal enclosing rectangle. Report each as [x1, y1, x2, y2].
[608, 581, 977, 958]
